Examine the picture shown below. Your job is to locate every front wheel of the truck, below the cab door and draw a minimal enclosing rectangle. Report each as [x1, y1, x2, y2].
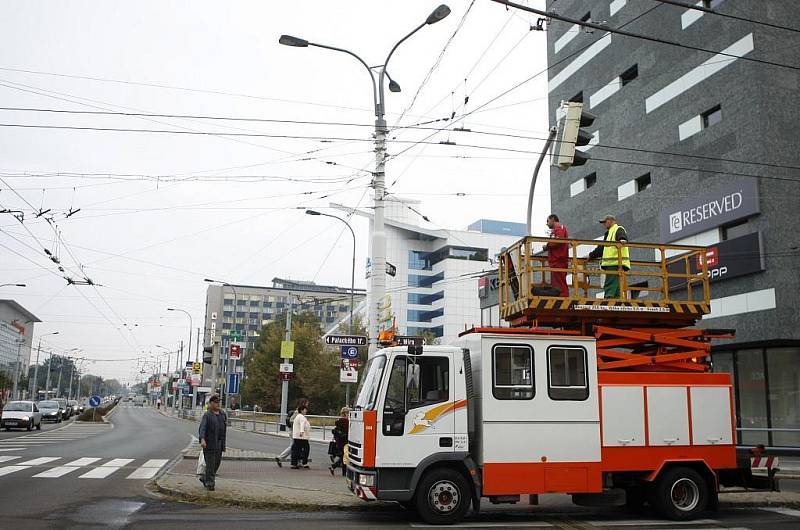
[415, 468, 472, 524]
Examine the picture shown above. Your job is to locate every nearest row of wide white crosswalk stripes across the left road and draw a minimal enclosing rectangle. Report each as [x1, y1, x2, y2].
[0, 455, 169, 480]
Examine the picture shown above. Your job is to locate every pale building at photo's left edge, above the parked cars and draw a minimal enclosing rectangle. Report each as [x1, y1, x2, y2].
[0, 300, 41, 379]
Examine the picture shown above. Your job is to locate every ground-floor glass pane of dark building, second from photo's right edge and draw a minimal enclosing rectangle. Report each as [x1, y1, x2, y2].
[736, 349, 768, 445]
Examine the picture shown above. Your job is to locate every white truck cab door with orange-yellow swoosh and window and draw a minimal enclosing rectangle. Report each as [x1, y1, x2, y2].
[376, 354, 466, 467]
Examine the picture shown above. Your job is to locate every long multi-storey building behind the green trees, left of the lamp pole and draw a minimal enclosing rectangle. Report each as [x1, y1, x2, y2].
[204, 278, 365, 354]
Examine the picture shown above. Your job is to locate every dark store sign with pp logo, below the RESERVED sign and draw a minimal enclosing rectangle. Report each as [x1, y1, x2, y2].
[668, 232, 766, 291]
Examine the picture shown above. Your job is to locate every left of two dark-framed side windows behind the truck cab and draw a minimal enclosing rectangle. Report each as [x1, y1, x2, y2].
[492, 344, 534, 399]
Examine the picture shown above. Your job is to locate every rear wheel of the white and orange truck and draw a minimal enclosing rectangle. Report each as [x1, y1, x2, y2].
[652, 467, 708, 521]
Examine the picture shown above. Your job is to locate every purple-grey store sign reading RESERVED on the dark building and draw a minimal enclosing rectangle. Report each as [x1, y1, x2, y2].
[659, 179, 761, 243]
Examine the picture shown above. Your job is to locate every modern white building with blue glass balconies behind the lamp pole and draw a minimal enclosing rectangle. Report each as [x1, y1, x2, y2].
[340, 196, 526, 344]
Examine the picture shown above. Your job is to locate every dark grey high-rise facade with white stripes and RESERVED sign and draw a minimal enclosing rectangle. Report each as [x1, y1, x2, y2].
[547, 0, 800, 447]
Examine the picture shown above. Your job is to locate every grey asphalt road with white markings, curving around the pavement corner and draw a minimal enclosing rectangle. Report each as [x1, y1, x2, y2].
[0, 403, 800, 530]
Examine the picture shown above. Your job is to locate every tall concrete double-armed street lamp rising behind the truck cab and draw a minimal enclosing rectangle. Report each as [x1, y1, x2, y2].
[278, 4, 450, 356]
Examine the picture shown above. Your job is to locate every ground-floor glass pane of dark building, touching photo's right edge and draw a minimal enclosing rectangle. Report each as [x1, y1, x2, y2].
[767, 348, 800, 447]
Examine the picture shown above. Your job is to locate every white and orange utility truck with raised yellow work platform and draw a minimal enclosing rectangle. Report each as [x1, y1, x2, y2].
[347, 237, 776, 524]
